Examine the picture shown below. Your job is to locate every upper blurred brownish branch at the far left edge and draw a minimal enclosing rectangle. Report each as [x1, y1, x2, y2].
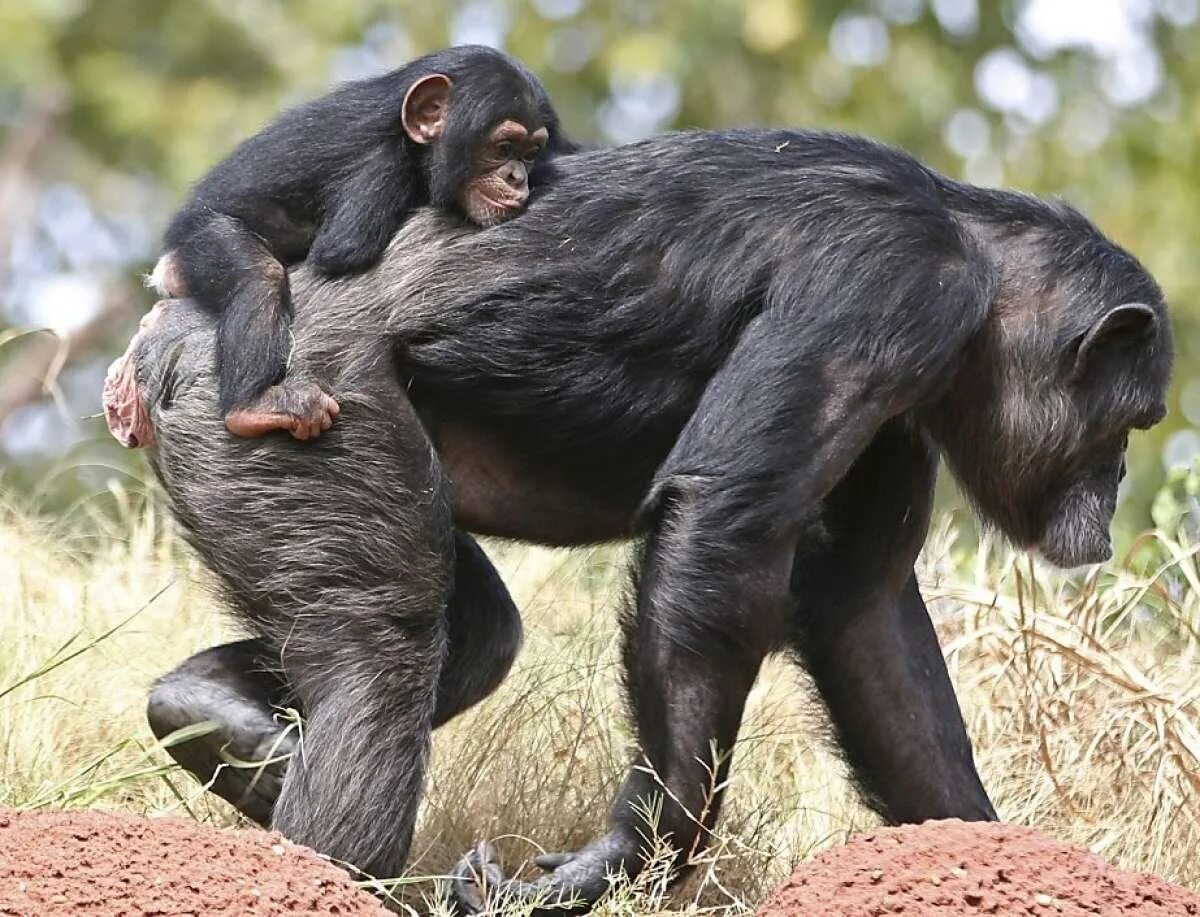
[0, 89, 67, 287]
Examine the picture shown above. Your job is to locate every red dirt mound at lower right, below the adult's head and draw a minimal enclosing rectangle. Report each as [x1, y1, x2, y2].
[758, 820, 1200, 917]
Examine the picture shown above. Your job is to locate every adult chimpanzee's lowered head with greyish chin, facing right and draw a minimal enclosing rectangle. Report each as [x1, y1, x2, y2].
[935, 210, 1172, 567]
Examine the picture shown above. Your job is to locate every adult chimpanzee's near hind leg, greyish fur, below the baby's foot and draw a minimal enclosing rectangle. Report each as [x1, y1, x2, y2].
[152, 358, 454, 876]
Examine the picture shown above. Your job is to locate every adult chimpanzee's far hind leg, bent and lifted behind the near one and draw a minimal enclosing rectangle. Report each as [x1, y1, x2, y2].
[146, 532, 521, 825]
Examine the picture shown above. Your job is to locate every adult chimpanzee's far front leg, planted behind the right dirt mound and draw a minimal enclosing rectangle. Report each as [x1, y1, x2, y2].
[792, 424, 996, 823]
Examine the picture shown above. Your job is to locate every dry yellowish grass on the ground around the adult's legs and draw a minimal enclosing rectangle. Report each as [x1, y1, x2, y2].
[0, 496, 1200, 915]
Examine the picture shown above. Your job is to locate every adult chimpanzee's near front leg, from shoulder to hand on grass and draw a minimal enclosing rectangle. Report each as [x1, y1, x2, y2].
[455, 304, 955, 909]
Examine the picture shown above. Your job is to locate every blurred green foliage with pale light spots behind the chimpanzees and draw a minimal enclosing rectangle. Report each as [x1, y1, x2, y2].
[0, 0, 1200, 544]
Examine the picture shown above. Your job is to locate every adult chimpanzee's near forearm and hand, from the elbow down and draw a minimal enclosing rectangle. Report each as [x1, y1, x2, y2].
[452, 478, 794, 913]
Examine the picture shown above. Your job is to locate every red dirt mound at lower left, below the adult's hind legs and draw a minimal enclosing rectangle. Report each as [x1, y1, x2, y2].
[0, 811, 386, 917]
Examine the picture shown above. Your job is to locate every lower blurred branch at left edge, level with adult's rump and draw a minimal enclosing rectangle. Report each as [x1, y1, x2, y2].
[0, 287, 133, 425]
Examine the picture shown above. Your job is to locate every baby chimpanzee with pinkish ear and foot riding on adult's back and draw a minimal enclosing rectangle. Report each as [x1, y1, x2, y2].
[152, 46, 571, 439]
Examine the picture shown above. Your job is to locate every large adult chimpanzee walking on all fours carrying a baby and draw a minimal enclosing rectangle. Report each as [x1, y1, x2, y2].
[103, 131, 1171, 904]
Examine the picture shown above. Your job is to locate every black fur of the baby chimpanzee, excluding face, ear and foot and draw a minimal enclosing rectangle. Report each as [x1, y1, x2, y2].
[164, 46, 574, 413]
